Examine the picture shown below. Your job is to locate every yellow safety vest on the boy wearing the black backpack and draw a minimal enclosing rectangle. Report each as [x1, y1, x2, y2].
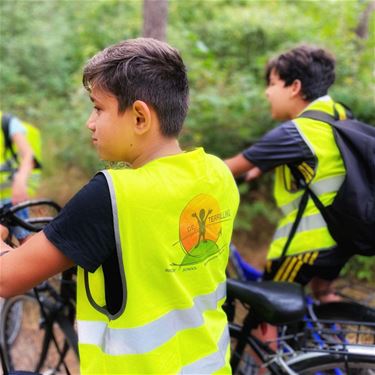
[268, 96, 346, 259]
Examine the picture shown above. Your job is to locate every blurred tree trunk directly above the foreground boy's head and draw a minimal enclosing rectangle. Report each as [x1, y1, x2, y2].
[143, 0, 168, 41]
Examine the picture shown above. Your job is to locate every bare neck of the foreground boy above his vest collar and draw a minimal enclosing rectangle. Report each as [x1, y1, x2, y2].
[131, 137, 182, 168]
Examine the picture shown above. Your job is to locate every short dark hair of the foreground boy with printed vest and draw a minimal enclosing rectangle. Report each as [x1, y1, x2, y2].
[82, 38, 189, 137]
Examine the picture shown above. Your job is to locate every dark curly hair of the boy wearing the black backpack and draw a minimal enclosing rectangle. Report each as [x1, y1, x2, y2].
[266, 45, 335, 101]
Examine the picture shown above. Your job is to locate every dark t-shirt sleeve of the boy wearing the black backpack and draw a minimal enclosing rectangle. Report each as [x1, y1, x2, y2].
[243, 121, 316, 172]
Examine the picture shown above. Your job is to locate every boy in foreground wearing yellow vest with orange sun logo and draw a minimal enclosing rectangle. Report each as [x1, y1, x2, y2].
[0, 38, 238, 374]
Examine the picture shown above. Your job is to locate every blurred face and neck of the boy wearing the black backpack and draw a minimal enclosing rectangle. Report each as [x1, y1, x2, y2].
[266, 69, 294, 120]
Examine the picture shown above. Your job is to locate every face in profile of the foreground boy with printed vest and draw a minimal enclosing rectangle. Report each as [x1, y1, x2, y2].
[87, 87, 135, 163]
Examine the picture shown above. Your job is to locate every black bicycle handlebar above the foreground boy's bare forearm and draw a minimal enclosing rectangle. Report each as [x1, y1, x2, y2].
[0, 199, 61, 232]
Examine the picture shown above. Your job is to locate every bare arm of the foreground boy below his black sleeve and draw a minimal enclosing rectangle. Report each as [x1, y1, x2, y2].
[0, 232, 74, 298]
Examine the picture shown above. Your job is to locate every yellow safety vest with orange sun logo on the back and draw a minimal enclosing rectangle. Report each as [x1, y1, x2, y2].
[77, 149, 239, 375]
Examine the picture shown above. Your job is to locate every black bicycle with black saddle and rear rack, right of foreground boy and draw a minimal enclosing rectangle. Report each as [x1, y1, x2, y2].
[227, 279, 375, 375]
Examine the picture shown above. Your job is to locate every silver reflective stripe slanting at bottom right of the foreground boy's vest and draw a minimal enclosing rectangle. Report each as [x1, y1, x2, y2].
[179, 326, 230, 374]
